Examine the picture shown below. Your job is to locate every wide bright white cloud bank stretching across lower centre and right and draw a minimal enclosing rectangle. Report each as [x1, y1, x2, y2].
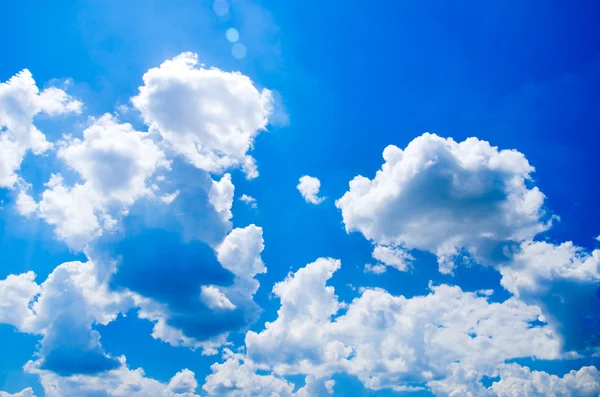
[246, 258, 560, 390]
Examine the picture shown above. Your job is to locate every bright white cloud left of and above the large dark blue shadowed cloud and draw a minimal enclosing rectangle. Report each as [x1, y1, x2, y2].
[39, 114, 169, 251]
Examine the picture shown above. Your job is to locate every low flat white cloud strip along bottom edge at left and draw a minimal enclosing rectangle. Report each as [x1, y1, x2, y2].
[25, 358, 198, 397]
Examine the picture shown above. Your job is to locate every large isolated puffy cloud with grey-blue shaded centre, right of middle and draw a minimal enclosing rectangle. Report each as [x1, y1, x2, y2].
[336, 133, 549, 273]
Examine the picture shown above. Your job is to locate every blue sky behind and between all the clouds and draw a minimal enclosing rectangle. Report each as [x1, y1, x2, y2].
[0, 0, 600, 397]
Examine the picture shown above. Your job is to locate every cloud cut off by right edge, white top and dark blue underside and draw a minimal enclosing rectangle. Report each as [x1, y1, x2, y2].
[499, 242, 600, 352]
